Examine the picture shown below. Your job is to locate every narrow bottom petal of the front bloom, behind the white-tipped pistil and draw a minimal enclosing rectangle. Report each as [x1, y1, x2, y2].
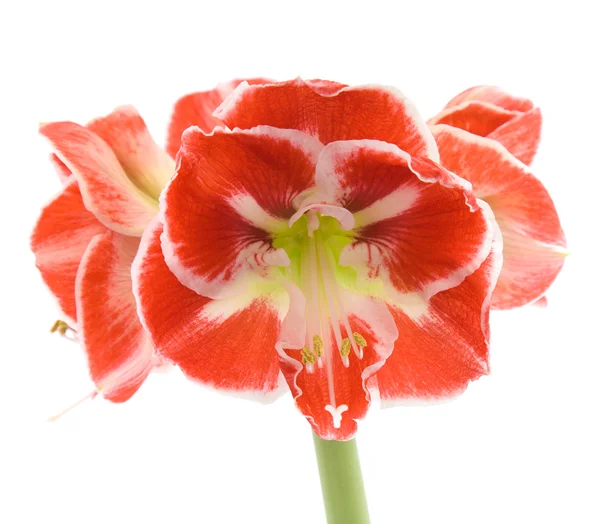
[278, 290, 398, 440]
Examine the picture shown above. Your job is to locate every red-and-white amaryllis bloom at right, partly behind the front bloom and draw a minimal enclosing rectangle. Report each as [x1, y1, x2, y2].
[429, 86, 567, 309]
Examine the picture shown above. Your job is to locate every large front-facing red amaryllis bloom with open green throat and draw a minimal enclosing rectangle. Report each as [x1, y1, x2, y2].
[133, 80, 500, 440]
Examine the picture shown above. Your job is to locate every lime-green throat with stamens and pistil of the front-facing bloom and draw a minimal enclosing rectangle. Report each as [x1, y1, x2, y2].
[274, 210, 367, 428]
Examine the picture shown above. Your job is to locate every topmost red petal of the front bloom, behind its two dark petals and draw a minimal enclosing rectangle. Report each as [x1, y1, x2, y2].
[214, 78, 438, 160]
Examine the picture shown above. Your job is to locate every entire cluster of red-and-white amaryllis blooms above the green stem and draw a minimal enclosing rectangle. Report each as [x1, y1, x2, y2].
[32, 79, 566, 440]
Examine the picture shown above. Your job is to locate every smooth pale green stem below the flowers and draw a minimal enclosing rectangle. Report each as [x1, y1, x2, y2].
[313, 434, 370, 524]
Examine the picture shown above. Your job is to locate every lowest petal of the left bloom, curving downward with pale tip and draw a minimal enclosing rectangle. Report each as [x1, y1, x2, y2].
[76, 231, 154, 402]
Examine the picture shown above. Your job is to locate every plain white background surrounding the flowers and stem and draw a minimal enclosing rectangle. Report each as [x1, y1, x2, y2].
[0, 0, 600, 524]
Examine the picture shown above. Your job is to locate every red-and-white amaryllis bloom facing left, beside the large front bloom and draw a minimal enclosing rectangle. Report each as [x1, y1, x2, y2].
[31, 107, 175, 402]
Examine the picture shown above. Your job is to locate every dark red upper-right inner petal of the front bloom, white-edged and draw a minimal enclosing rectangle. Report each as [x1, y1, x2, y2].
[317, 140, 493, 298]
